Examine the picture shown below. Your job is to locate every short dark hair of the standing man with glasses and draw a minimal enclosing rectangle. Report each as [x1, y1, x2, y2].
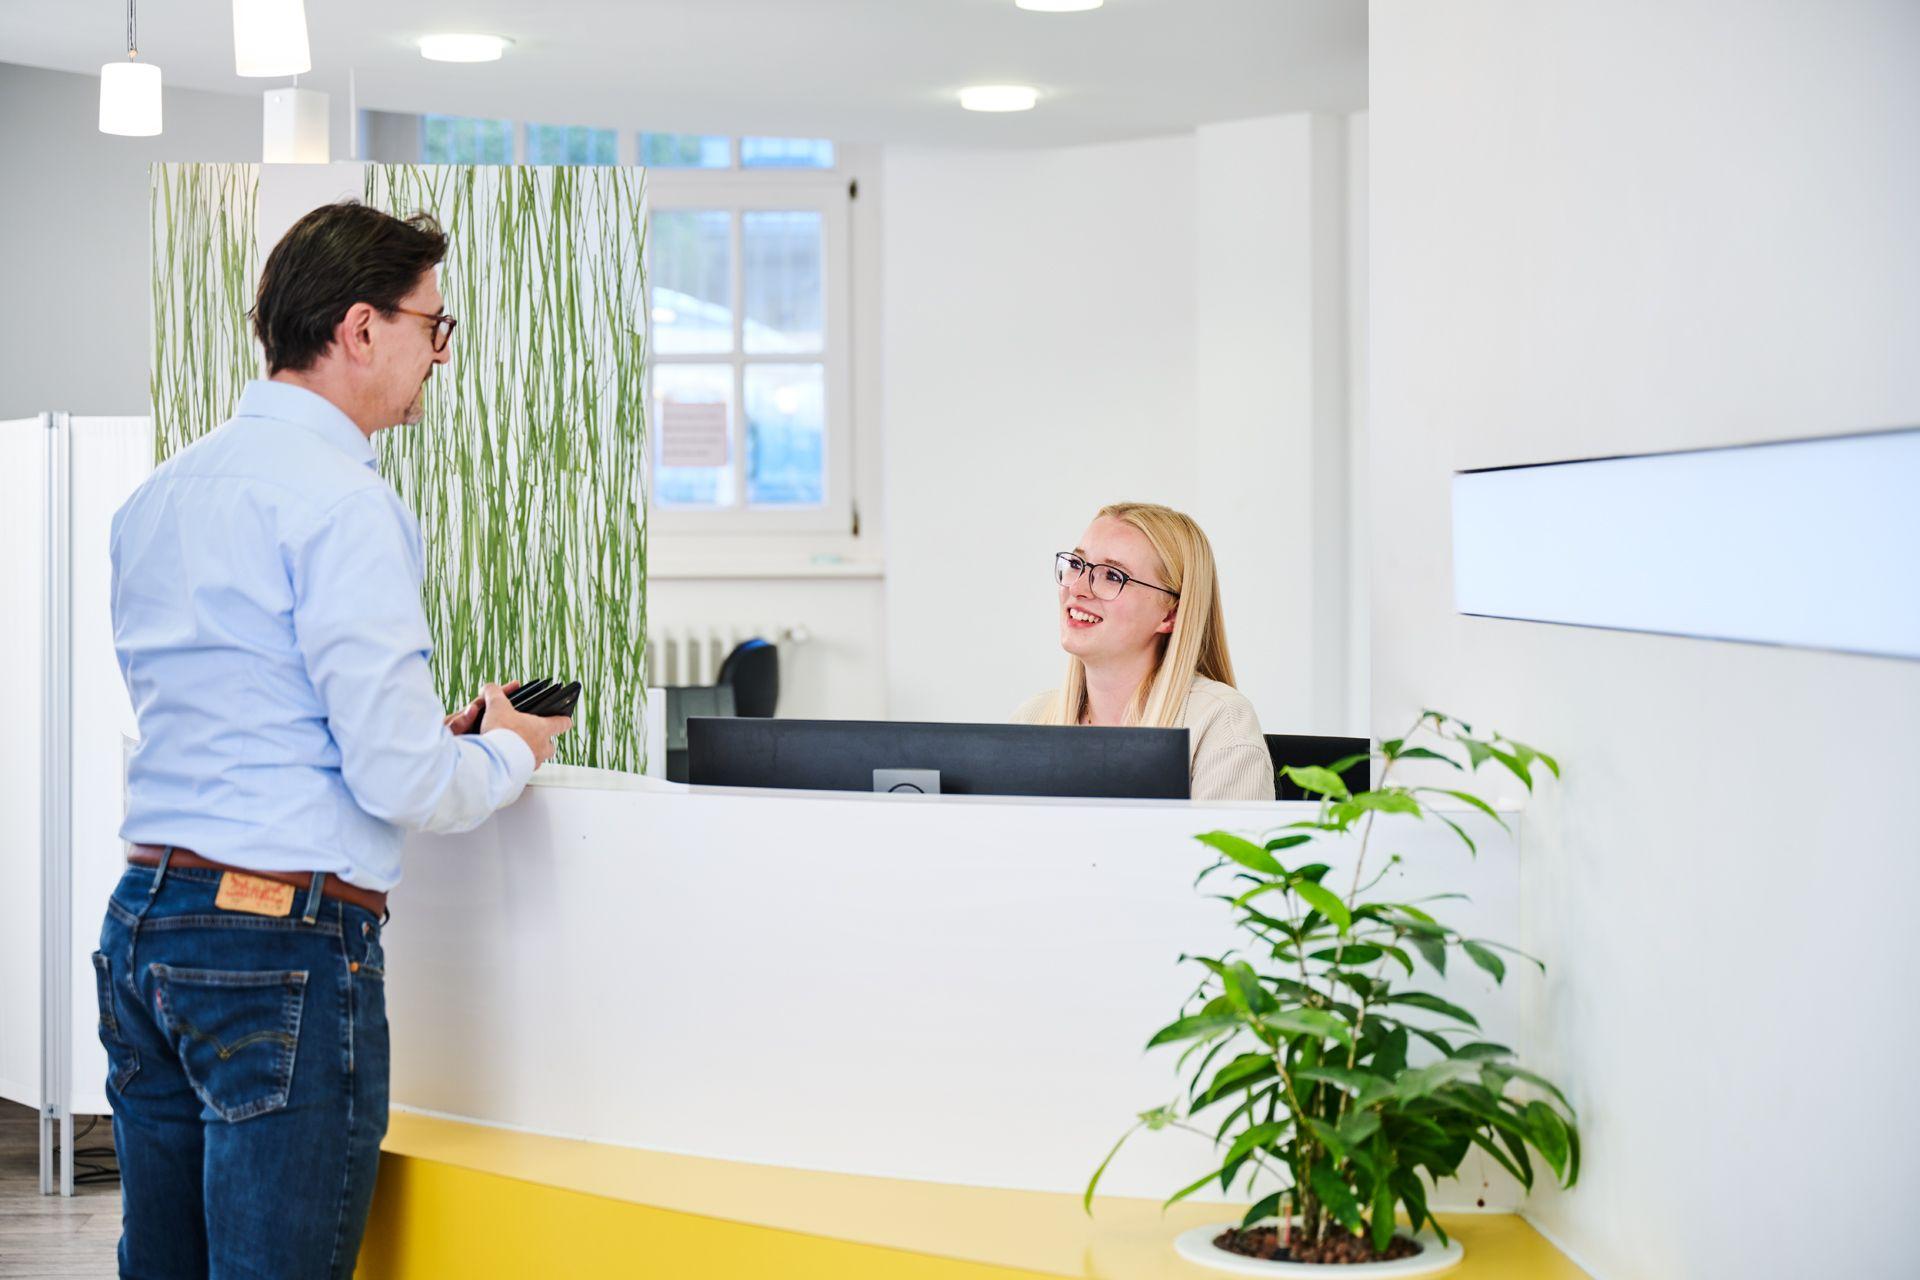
[253, 200, 447, 374]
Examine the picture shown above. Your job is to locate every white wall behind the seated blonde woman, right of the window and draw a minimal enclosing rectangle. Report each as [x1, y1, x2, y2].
[883, 117, 1357, 731]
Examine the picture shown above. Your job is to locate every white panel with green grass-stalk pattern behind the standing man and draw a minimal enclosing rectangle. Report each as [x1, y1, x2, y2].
[154, 165, 647, 770]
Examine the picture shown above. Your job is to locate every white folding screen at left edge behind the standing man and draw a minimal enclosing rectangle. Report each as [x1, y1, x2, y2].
[0, 413, 154, 1194]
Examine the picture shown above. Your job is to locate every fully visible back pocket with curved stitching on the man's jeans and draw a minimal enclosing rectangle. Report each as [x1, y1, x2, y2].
[148, 963, 307, 1121]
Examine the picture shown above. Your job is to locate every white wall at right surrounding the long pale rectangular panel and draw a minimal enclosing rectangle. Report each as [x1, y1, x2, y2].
[1369, 0, 1920, 1280]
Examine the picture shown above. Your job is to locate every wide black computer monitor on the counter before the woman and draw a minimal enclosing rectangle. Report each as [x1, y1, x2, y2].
[687, 718, 1188, 800]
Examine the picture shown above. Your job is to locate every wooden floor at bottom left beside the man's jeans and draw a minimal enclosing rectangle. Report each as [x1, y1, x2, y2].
[0, 1102, 119, 1280]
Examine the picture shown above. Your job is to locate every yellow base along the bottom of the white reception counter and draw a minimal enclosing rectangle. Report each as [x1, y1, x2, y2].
[357, 1111, 1586, 1280]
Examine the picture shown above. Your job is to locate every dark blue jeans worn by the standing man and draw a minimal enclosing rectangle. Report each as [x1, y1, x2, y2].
[94, 867, 388, 1280]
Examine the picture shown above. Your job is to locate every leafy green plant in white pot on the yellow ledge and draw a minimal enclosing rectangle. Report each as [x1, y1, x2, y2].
[1085, 710, 1580, 1274]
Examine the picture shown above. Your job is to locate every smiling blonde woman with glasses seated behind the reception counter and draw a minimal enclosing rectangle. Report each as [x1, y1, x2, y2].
[1014, 503, 1273, 800]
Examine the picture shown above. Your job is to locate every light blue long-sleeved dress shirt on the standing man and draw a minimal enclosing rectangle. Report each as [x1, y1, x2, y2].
[113, 382, 534, 890]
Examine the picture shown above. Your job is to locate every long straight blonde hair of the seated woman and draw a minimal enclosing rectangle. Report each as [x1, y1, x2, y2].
[1048, 503, 1233, 729]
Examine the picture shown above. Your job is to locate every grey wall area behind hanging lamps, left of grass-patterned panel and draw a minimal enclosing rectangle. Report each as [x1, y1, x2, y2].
[0, 62, 261, 416]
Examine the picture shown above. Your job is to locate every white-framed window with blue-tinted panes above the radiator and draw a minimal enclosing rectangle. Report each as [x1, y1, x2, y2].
[641, 153, 852, 532]
